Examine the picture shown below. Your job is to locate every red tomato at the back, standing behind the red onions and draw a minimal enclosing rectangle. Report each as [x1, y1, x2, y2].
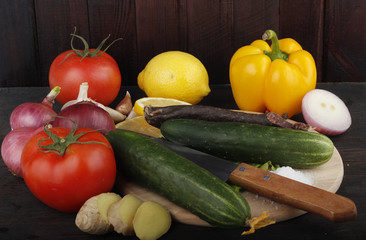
[49, 49, 121, 106]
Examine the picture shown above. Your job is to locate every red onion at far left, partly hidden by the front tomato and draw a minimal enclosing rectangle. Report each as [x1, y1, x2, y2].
[1, 127, 43, 177]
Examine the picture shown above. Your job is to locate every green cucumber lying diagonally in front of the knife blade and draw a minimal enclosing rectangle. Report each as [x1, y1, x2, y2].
[106, 129, 250, 228]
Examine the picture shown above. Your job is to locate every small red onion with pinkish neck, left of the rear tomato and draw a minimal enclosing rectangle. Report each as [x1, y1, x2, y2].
[10, 87, 61, 130]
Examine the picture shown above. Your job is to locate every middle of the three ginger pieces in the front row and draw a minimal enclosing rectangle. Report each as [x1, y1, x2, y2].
[108, 194, 142, 236]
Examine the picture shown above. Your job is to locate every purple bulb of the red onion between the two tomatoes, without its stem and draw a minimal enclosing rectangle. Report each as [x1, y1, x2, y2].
[52, 102, 116, 133]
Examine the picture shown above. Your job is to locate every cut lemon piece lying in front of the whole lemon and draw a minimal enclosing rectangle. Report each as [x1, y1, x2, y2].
[133, 97, 191, 115]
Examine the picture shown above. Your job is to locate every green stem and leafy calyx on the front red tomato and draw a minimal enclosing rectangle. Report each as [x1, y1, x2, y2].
[38, 116, 108, 156]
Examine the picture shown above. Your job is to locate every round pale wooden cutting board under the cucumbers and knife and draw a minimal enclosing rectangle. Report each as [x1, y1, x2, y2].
[116, 145, 344, 226]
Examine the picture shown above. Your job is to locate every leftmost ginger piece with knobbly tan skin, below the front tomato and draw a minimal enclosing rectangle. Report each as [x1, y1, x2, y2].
[75, 192, 121, 234]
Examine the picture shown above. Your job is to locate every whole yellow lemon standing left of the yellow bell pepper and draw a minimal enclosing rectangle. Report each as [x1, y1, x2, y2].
[137, 51, 211, 104]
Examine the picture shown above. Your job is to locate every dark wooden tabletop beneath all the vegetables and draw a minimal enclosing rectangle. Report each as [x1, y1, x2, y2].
[0, 83, 366, 240]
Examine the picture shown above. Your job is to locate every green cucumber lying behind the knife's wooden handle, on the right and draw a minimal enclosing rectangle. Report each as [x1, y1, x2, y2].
[160, 119, 334, 168]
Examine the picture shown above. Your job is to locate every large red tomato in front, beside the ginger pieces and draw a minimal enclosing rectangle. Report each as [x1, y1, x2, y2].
[21, 127, 116, 212]
